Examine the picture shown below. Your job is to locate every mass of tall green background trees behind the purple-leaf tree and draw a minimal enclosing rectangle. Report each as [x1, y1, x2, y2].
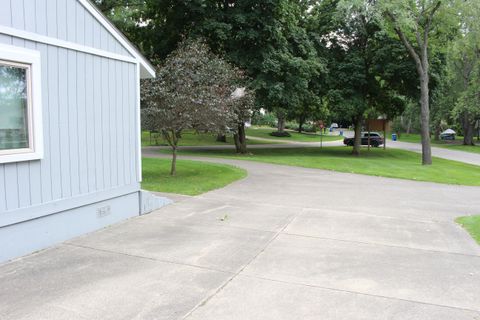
[95, 0, 479, 164]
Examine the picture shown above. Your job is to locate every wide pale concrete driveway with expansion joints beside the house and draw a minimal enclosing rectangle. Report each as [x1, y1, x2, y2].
[0, 159, 480, 320]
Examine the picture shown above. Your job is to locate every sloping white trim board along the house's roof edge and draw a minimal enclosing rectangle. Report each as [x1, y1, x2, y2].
[77, 0, 155, 79]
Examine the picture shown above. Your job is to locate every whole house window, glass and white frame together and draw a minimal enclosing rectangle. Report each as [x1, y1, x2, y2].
[0, 45, 43, 163]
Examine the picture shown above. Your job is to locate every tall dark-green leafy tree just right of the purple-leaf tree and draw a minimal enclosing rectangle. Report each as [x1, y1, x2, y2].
[203, 0, 324, 131]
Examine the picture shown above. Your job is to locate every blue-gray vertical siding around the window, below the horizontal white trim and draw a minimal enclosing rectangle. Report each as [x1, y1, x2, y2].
[0, 35, 138, 227]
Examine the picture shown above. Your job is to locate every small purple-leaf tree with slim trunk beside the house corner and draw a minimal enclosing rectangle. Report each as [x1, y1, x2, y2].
[141, 40, 247, 175]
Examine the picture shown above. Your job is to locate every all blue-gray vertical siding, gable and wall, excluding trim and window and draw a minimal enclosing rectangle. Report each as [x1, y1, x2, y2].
[0, 0, 139, 222]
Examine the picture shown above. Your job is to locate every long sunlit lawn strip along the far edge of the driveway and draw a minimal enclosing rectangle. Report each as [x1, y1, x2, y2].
[170, 147, 480, 186]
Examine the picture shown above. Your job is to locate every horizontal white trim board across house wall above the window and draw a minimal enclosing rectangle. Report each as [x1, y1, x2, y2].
[0, 26, 137, 63]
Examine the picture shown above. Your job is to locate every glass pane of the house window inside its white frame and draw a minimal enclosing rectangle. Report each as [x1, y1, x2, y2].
[0, 61, 29, 150]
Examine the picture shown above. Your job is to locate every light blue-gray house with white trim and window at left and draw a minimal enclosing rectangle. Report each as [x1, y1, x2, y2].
[0, 0, 169, 261]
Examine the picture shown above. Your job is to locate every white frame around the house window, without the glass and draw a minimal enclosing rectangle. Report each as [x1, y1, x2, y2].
[0, 44, 43, 163]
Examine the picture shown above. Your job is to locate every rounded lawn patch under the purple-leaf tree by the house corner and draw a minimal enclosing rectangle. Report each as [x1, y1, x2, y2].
[142, 158, 247, 196]
